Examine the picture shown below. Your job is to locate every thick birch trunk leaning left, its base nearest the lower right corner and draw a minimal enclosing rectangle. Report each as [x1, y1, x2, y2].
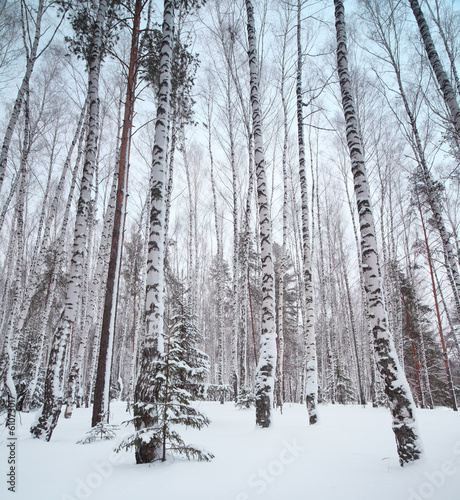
[334, 0, 421, 465]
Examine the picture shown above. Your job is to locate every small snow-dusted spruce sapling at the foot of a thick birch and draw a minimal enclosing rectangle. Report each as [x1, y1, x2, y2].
[116, 304, 214, 462]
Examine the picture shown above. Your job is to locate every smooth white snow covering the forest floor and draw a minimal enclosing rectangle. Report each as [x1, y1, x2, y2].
[0, 402, 460, 500]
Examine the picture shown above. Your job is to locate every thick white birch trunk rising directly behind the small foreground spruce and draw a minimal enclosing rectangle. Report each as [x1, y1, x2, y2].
[134, 0, 174, 463]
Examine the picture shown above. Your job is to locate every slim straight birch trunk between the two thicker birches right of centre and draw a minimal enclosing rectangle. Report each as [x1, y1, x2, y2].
[296, 0, 318, 424]
